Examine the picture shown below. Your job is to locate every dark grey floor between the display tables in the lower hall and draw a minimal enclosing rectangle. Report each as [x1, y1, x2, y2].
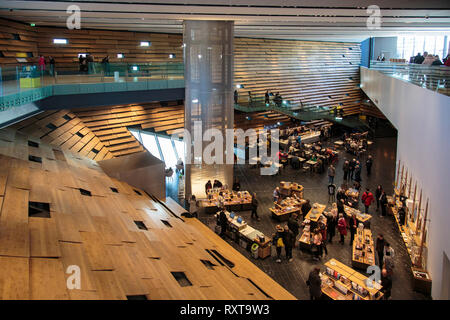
[195, 138, 426, 300]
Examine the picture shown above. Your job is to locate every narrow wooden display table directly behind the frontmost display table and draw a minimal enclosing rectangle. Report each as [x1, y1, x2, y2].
[352, 228, 375, 271]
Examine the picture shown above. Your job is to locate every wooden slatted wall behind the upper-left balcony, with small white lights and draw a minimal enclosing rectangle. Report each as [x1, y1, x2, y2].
[0, 19, 183, 67]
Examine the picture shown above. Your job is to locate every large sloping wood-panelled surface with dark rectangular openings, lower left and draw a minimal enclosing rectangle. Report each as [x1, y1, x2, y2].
[0, 129, 294, 299]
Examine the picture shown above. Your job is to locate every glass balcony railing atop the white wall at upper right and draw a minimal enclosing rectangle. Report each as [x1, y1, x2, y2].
[370, 61, 450, 96]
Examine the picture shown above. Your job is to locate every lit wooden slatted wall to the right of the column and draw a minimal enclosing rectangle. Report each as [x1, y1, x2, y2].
[234, 38, 361, 112]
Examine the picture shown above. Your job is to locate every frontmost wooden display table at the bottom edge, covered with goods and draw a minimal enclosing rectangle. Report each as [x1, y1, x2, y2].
[321, 259, 383, 300]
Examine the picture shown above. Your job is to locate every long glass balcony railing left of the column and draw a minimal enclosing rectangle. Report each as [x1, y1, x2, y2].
[0, 62, 184, 110]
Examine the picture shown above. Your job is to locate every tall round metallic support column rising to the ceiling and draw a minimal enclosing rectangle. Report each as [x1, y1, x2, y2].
[183, 21, 234, 197]
